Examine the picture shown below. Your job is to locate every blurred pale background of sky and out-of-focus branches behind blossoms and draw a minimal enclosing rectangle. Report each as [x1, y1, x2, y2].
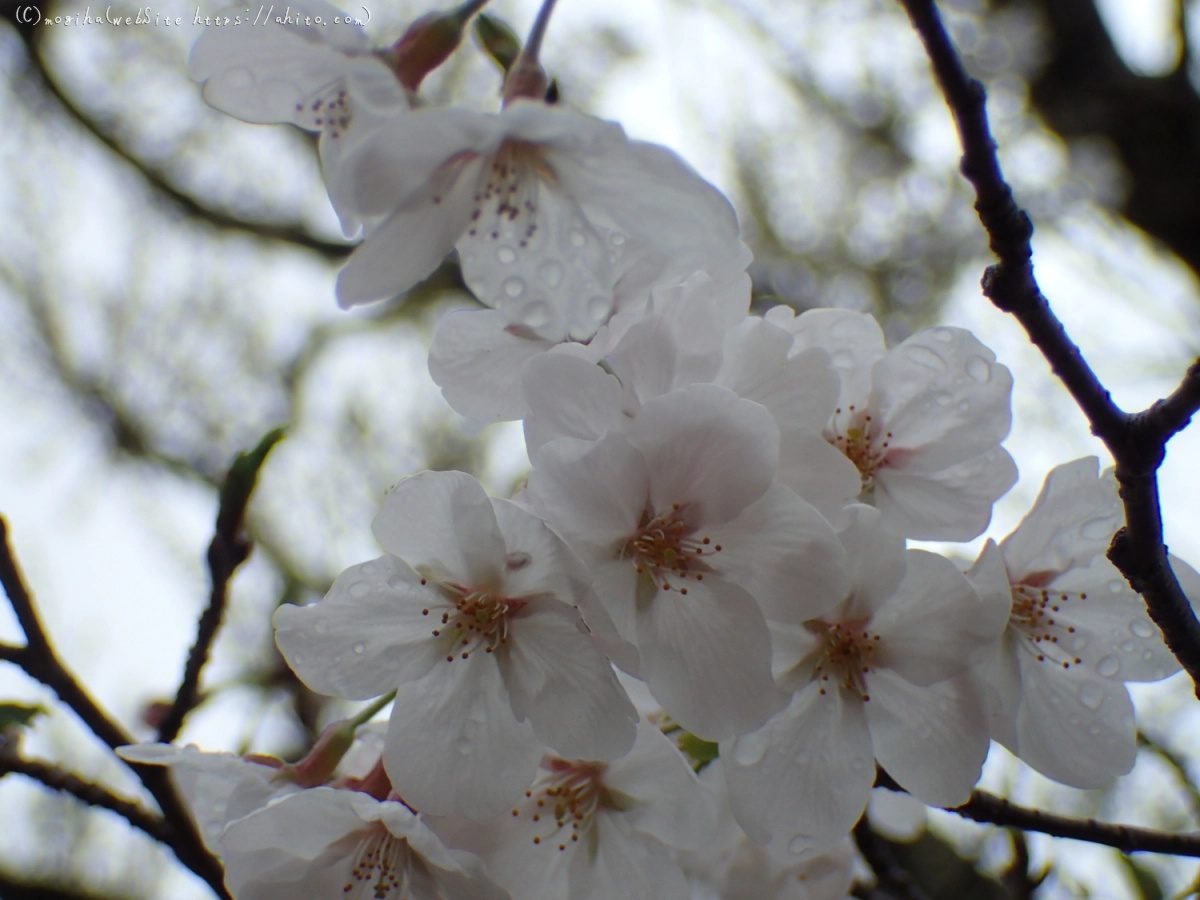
[0, 0, 1200, 900]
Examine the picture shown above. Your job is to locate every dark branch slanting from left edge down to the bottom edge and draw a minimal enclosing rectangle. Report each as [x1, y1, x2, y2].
[0, 516, 229, 900]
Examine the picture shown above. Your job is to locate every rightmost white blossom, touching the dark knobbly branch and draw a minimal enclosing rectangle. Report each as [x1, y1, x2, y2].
[967, 456, 1194, 787]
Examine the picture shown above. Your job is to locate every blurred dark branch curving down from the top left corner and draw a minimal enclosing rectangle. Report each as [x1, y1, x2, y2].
[2, 5, 354, 262]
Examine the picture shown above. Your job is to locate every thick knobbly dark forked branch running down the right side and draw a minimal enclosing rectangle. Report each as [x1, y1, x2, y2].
[900, 0, 1200, 695]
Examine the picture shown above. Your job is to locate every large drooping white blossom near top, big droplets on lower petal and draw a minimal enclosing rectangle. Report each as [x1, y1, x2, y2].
[335, 100, 749, 342]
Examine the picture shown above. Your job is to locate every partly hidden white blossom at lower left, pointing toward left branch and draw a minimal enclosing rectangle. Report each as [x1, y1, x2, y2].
[116, 744, 301, 853]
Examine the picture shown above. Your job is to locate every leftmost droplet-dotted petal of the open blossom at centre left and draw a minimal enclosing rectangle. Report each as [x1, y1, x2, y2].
[274, 556, 449, 700]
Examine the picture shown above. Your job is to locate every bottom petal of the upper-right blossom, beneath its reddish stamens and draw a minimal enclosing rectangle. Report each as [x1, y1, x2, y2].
[875, 445, 1016, 541]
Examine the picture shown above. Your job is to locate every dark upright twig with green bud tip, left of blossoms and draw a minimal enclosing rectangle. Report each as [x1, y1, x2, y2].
[158, 428, 283, 744]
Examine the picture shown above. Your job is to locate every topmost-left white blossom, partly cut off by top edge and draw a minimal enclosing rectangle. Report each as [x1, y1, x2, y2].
[188, 0, 409, 235]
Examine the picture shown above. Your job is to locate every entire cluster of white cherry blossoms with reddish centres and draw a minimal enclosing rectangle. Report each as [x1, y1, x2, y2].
[124, 0, 1192, 900]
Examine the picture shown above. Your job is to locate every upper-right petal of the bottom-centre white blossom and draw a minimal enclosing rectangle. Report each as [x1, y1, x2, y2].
[605, 719, 718, 850]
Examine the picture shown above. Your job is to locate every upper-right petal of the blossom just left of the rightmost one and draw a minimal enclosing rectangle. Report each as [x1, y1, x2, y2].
[870, 550, 1012, 684]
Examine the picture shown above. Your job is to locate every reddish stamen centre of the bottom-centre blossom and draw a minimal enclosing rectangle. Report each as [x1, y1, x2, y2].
[512, 756, 619, 851]
